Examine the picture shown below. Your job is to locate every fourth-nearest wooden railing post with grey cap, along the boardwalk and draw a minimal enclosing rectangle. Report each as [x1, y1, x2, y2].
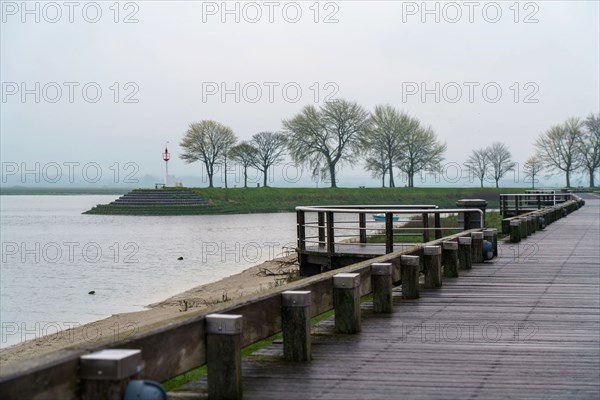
[333, 273, 360, 333]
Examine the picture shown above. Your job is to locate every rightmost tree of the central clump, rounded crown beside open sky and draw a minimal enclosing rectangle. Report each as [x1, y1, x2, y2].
[396, 118, 446, 187]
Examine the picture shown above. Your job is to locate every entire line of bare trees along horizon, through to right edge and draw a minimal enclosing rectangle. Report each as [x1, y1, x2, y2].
[180, 100, 600, 187]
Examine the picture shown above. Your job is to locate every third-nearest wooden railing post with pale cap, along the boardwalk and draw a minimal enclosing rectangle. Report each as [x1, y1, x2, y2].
[281, 290, 311, 361]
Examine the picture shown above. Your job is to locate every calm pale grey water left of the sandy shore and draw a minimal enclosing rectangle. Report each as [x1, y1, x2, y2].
[0, 195, 296, 347]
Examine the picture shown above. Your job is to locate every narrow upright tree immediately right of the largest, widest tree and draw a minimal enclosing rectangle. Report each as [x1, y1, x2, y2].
[361, 105, 402, 188]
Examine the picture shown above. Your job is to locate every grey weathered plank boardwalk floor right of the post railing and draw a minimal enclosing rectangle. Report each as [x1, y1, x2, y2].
[178, 196, 600, 400]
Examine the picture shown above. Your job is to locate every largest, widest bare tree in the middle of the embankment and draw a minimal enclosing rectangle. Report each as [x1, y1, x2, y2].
[283, 100, 370, 188]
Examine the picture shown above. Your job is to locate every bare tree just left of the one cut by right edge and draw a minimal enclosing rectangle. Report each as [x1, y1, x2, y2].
[535, 118, 583, 187]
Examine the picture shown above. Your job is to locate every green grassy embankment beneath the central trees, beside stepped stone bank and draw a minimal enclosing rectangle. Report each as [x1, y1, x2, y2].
[87, 188, 524, 215]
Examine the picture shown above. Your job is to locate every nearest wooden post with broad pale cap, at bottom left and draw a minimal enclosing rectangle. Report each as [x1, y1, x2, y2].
[79, 349, 142, 400]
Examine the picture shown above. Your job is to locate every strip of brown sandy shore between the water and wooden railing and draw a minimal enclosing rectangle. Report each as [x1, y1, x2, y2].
[0, 254, 298, 367]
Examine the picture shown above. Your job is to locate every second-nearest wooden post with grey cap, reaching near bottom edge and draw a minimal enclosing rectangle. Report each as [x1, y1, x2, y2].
[205, 314, 242, 400]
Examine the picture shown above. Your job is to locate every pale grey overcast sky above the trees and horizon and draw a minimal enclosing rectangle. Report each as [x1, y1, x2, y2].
[1, 1, 600, 186]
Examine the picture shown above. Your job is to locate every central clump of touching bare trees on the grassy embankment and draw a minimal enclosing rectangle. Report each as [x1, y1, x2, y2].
[180, 100, 446, 187]
